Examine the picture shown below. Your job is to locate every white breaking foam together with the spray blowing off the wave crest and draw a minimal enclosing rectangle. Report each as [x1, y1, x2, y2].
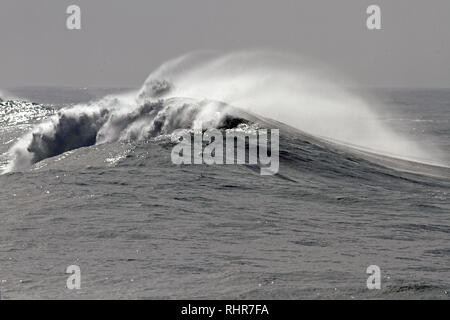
[5, 52, 446, 172]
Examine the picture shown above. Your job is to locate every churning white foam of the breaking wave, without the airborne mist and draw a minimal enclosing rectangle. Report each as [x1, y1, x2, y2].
[4, 92, 250, 173]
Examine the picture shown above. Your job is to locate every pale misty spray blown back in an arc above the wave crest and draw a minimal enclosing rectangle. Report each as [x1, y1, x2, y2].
[141, 51, 443, 164]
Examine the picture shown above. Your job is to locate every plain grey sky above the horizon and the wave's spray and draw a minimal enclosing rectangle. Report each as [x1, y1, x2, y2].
[0, 0, 450, 88]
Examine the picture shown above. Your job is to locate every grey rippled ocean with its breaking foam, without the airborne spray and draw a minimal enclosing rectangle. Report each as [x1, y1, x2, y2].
[0, 80, 450, 299]
